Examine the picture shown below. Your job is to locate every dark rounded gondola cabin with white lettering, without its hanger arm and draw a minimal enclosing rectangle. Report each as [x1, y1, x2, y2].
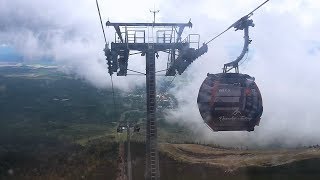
[197, 73, 263, 131]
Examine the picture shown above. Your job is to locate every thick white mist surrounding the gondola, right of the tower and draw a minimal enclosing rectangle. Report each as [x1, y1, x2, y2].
[161, 1, 320, 147]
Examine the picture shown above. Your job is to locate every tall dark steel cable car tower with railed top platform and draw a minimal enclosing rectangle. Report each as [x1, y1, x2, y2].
[104, 21, 208, 180]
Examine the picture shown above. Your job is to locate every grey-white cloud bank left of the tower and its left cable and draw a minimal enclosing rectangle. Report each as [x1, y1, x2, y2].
[0, 0, 150, 91]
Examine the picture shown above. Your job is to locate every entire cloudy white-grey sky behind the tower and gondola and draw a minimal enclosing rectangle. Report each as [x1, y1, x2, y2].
[0, 0, 320, 146]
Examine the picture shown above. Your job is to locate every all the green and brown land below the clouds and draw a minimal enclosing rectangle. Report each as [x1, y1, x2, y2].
[0, 67, 320, 180]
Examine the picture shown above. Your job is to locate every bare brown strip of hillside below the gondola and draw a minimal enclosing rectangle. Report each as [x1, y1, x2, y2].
[160, 143, 320, 171]
